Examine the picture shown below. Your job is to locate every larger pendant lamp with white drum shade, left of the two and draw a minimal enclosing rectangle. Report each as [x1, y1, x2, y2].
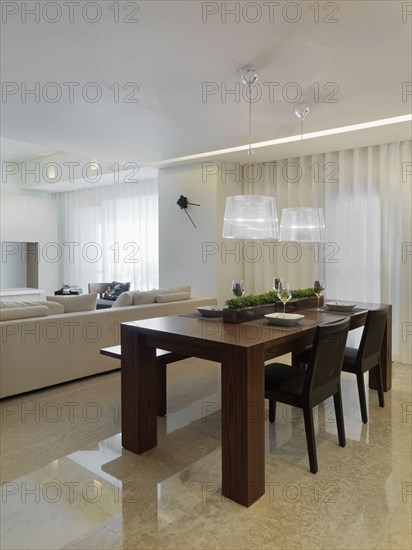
[222, 65, 279, 239]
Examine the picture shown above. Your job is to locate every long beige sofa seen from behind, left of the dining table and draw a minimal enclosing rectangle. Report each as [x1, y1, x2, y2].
[0, 295, 216, 398]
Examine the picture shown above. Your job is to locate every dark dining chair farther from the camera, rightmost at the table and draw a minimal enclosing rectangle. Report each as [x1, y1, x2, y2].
[342, 306, 388, 424]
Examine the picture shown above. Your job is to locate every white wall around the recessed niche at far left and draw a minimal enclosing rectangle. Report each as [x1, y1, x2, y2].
[0, 170, 58, 294]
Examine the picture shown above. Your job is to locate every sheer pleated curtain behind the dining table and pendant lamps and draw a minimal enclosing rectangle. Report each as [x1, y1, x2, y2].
[244, 141, 412, 364]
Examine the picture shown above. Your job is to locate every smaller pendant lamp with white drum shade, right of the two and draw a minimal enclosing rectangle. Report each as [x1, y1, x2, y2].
[280, 104, 326, 243]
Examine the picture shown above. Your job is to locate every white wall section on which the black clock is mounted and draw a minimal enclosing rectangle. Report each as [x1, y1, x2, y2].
[159, 163, 243, 305]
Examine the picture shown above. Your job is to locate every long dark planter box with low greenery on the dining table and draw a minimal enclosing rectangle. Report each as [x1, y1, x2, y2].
[223, 288, 323, 323]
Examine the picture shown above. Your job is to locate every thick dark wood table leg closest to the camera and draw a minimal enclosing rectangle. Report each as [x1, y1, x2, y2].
[222, 345, 265, 506]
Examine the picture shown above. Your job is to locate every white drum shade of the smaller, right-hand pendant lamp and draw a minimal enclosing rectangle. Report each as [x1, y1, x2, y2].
[280, 207, 326, 243]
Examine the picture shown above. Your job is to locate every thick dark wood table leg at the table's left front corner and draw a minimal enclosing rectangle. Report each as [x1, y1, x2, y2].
[121, 325, 157, 454]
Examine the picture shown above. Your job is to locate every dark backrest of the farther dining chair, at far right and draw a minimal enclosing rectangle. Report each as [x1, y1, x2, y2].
[356, 306, 388, 368]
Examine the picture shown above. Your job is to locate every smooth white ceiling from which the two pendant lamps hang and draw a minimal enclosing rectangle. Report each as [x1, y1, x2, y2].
[1, 0, 412, 165]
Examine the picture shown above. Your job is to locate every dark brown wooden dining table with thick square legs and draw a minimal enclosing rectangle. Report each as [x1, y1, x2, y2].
[121, 308, 386, 506]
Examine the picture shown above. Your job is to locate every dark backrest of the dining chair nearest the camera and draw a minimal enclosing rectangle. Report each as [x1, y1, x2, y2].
[303, 317, 350, 404]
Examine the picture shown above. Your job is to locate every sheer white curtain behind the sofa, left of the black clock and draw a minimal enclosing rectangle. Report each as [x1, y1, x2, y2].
[57, 180, 159, 292]
